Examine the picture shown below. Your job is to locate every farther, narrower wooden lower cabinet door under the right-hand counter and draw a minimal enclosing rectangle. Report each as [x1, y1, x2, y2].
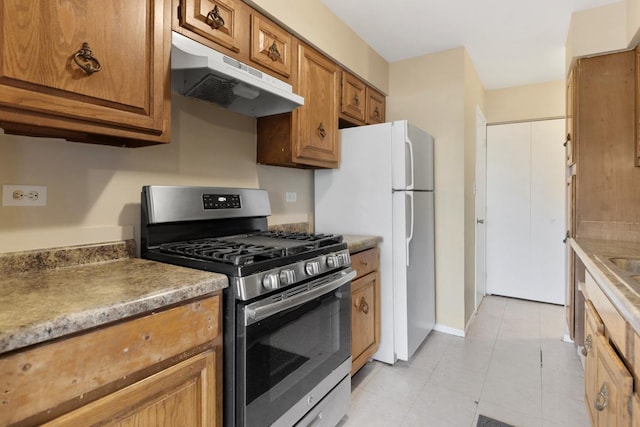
[582, 301, 604, 423]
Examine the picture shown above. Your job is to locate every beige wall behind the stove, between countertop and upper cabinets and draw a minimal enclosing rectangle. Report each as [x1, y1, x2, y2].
[0, 95, 313, 252]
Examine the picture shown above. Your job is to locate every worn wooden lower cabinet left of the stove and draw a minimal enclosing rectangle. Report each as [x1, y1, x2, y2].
[0, 293, 222, 426]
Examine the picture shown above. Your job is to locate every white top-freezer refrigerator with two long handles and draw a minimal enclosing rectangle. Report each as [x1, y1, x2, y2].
[314, 120, 435, 364]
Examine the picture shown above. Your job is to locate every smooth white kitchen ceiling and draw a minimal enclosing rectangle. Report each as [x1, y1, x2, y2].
[322, 0, 620, 89]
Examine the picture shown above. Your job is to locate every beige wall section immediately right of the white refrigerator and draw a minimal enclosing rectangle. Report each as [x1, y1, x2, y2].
[387, 48, 465, 329]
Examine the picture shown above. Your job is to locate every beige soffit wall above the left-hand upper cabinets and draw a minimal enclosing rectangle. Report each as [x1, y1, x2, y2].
[247, 0, 389, 93]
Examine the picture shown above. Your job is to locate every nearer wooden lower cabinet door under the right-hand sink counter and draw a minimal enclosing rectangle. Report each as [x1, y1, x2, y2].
[587, 336, 633, 427]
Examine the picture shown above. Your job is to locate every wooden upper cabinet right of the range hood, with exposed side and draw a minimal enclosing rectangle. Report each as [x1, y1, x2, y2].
[258, 43, 340, 168]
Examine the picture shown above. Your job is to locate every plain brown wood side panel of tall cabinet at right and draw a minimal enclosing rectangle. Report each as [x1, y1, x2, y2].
[571, 51, 640, 241]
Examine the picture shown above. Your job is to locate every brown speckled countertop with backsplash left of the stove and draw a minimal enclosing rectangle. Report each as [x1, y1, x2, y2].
[0, 241, 228, 353]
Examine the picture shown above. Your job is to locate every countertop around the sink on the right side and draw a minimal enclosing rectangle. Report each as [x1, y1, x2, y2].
[569, 238, 640, 334]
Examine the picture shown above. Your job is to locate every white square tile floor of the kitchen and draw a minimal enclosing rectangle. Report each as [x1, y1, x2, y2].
[340, 296, 590, 427]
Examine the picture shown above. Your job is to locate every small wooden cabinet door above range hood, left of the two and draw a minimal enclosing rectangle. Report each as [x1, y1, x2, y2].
[178, 0, 240, 53]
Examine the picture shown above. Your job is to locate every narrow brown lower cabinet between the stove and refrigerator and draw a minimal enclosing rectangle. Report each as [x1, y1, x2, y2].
[351, 247, 380, 375]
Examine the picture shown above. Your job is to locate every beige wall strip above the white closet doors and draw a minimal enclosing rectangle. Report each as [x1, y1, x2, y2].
[484, 80, 565, 124]
